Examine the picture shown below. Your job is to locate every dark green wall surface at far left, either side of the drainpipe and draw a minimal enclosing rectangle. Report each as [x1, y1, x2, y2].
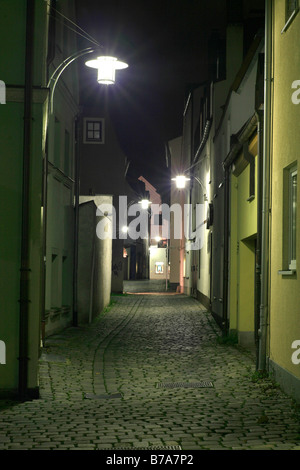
[0, 0, 47, 394]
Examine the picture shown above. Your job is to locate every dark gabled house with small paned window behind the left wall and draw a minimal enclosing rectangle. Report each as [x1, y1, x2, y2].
[79, 104, 149, 293]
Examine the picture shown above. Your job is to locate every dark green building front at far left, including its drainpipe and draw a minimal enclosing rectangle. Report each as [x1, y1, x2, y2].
[0, 1, 48, 399]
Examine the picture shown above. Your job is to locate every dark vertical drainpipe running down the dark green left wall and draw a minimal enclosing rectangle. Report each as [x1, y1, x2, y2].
[18, 0, 34, 401]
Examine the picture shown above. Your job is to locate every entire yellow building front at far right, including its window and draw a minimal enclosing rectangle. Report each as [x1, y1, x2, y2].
[265, 0, 300, 400]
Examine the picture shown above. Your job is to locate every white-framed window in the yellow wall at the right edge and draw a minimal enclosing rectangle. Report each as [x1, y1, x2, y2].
[289, 167, 297, 270]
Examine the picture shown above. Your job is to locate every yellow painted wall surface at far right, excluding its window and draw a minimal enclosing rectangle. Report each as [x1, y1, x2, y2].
[269, 0, 300, 378]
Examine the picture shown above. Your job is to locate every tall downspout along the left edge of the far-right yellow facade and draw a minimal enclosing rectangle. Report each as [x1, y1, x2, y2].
[258, 0, 272, 371]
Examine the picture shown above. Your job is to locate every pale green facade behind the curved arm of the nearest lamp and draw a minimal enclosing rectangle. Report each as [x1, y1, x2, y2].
[42, 1, 79, 339]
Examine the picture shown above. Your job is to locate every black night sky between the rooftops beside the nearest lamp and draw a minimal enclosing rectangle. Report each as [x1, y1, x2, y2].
[77, 0, 263, 195]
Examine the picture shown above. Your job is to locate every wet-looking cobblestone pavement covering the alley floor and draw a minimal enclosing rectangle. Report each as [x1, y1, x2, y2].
[0, 280, 300, 451]
